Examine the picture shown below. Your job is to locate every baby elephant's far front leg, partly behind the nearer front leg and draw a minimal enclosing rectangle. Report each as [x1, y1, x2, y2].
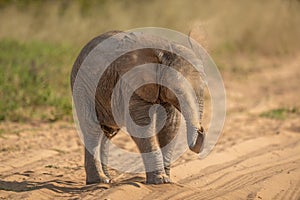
[157, 103, 180, 177]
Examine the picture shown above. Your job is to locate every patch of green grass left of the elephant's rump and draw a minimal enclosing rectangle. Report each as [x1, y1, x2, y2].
[0, 40, 75, 121]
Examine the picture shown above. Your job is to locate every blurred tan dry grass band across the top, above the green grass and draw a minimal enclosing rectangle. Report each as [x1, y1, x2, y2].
[0, 0, 300, 55]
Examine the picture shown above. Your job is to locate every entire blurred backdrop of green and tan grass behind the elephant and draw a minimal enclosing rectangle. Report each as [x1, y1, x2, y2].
[0, 0, 300, 121]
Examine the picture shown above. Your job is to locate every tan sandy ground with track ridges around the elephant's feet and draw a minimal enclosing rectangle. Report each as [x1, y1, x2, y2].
[0, 57, 300, 200]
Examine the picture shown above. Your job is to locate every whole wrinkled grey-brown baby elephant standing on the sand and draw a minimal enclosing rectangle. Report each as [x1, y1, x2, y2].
[71, 31, 205, 184]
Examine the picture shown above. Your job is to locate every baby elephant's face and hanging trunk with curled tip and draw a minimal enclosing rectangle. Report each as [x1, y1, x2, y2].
[155, 45, 205, 153]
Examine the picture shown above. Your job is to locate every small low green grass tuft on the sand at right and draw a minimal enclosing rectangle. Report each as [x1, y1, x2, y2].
[260, 108, 300, 120]
